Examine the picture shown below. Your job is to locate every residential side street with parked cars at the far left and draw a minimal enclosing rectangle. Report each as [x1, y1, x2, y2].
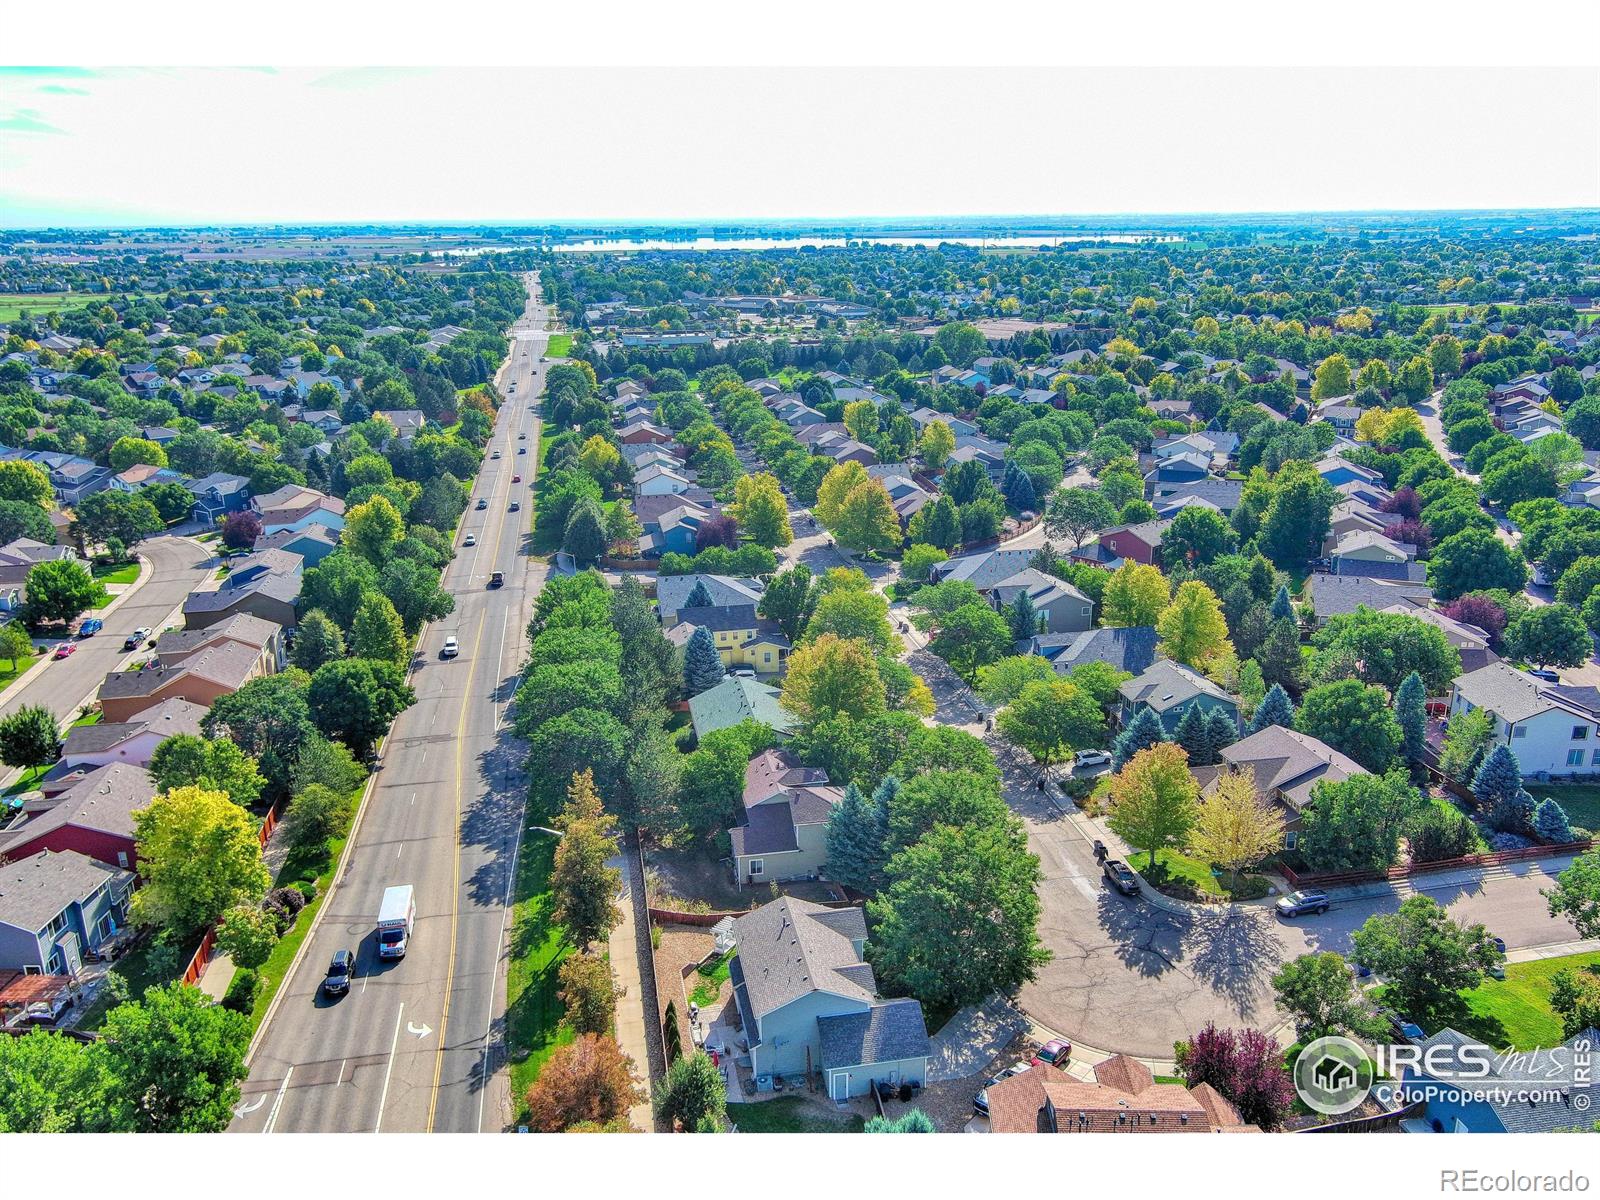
[0, 536, 218, 732]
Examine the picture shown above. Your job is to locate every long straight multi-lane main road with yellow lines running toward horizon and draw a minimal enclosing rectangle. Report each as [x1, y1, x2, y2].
[232, 277, 549, 1133]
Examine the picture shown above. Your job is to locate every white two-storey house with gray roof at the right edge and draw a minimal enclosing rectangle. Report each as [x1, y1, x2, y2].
[1450, 662, 1600, 778]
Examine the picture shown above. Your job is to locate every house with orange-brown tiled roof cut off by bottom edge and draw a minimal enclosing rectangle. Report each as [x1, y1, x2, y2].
[987, 1054, 1259, 1133]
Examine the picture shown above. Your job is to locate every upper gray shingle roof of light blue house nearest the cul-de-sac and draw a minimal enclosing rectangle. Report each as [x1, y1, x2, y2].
[733, 896, 877, 1018]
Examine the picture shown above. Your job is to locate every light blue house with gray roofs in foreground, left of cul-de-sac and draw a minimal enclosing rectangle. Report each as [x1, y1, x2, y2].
[728, 896, 930, 1101]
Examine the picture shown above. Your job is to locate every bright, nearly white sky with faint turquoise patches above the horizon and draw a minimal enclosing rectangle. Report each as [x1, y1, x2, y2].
[0, 64, 1600, 227]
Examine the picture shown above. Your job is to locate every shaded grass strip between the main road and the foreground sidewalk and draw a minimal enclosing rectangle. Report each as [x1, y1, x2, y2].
[506, 814, 573, 1115]
